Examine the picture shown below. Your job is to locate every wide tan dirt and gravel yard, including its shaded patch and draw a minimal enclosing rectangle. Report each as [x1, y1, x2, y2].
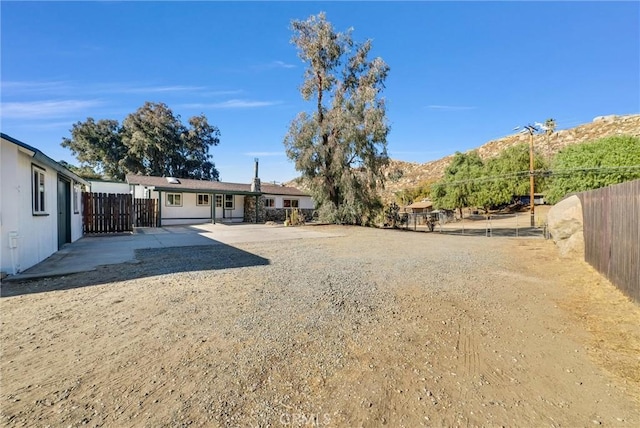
[0, 226, 640, 427]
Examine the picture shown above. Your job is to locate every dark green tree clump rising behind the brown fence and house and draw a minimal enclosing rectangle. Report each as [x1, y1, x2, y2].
[62, 102, 220, 180]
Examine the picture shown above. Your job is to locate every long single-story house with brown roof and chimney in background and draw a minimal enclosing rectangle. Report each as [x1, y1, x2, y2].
[122, 174, 315, 226]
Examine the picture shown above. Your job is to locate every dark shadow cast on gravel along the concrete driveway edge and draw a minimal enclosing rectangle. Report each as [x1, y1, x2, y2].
[0, 243, 269, 297]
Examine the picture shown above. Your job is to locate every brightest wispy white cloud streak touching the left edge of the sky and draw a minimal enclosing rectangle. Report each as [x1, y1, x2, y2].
[0, 100, 102, 119]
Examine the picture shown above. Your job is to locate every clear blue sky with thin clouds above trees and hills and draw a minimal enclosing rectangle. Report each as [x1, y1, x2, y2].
[0, 1, 640, 182]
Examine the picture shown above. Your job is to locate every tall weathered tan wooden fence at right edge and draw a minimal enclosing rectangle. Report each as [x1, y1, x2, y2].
[578, 180, 640, 303]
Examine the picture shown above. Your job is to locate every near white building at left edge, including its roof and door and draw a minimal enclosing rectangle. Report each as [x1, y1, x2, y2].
[0, 133, 89, 275]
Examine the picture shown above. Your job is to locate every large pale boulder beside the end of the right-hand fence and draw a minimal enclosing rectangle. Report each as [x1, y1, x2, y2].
[547, 195, 584, 257]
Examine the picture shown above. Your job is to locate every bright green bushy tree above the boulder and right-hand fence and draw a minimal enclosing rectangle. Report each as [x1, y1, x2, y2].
[545, 135, 640, 204]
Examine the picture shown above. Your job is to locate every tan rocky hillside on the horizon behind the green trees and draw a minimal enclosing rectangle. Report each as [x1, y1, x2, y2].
[286, 115, 640, 201]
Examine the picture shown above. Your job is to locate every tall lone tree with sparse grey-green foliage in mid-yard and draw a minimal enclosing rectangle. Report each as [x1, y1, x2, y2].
[284, 13, 389, 224]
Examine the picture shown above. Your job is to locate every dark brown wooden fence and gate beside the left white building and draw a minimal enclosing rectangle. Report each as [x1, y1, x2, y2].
[82, 193, 157, 234]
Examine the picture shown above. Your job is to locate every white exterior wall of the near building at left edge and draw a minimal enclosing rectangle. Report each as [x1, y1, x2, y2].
[0, 140, 82, 274]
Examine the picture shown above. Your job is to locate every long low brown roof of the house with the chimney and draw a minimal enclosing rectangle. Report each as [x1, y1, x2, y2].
[126, 174, 306, 196]
